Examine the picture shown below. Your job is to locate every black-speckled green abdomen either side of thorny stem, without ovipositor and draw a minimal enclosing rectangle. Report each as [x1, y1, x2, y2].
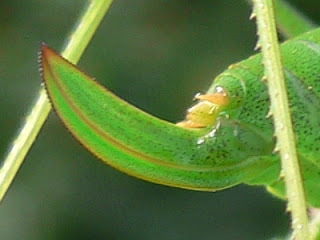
[209, 29, 320, 206]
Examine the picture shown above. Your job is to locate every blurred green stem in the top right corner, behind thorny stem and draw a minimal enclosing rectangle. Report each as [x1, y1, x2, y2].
[274, 0, 317, 38]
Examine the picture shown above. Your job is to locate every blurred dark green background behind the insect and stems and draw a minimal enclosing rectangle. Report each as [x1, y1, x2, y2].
[0, 0, 320, 240]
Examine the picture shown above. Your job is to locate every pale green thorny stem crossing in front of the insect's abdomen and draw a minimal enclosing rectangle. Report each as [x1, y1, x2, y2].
[253, 0, 310, 240]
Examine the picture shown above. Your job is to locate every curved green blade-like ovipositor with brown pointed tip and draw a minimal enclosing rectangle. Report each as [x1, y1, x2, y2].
[41, 45, 272, 190]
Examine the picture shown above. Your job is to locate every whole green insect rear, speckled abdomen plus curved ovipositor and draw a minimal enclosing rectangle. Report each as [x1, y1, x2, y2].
[41, 29, 320, 207]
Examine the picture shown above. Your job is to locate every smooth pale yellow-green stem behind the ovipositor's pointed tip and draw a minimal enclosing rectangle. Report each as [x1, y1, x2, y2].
[0, 0, 112, 202]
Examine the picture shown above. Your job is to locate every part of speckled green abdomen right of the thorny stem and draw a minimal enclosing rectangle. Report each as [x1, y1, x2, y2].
[270, 32, 320, 207]
